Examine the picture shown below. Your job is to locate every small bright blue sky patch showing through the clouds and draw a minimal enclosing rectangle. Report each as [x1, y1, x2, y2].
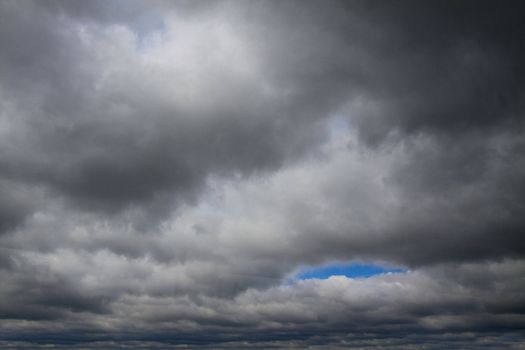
[296, 263, 407, 280]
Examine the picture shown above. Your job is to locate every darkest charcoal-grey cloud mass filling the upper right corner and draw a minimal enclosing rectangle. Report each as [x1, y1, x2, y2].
[230, 1, 524, 145]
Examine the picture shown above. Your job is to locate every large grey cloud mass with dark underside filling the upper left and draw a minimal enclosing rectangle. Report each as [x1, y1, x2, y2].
[2, 3, 328, 219]
